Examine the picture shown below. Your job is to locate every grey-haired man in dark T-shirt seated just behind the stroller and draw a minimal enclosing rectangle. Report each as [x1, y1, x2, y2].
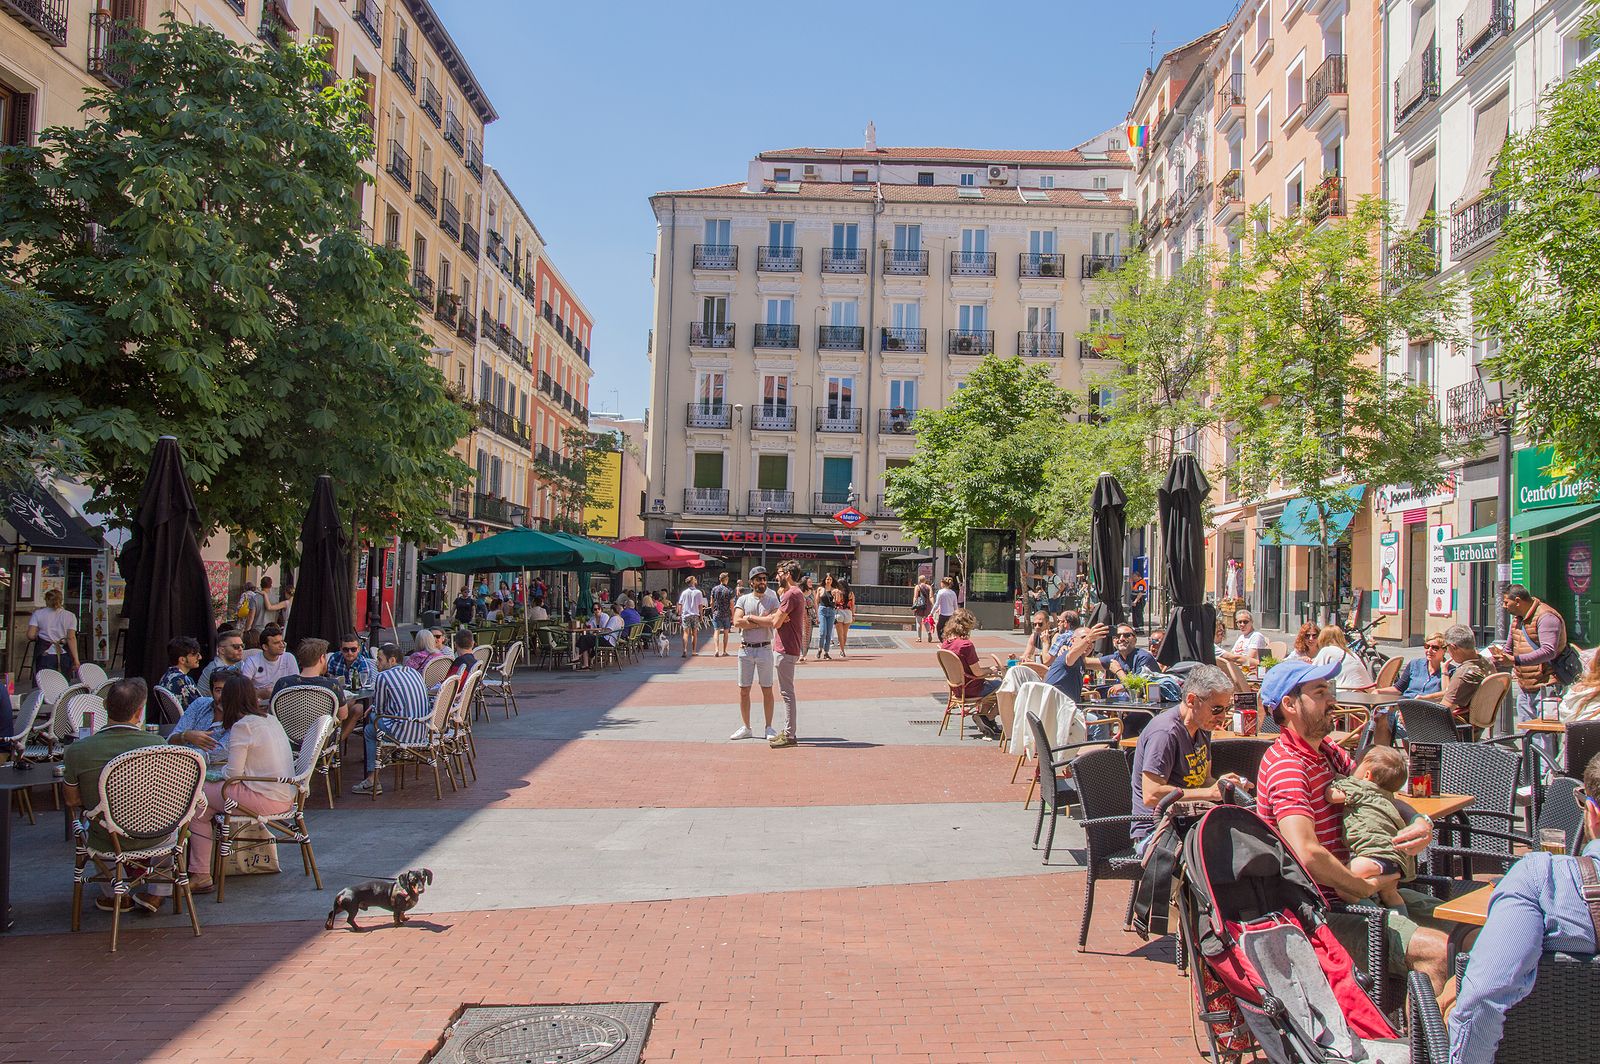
[1128, 666, 1250, 856]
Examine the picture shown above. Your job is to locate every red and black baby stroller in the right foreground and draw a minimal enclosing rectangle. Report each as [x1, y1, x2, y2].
[1134, 794, 1426, 1064]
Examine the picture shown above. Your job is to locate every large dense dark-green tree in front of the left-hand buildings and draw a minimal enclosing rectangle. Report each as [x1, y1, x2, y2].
[0, 18, 470, 560]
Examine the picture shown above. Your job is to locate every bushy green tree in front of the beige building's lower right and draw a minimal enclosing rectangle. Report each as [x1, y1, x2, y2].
[883, 355, 1074, 552]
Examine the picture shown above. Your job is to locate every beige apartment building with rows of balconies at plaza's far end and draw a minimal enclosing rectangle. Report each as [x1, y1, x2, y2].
[646, 135, 1133, 582]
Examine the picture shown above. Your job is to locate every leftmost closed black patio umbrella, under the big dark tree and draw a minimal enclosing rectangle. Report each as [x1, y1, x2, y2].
[118, 435, 216, 686]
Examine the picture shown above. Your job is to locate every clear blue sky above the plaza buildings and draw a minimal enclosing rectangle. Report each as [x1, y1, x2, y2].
[434, 0, 1234, 416]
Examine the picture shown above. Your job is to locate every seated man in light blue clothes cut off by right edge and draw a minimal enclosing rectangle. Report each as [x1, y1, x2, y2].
[1450, 755, 1600, 1064]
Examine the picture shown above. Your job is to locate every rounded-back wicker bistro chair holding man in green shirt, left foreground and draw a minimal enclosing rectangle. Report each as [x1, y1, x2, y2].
[72, 746, 205, 954]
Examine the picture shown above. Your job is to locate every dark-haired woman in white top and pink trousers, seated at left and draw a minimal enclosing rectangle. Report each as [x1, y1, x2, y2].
[189, 675, 294, 894]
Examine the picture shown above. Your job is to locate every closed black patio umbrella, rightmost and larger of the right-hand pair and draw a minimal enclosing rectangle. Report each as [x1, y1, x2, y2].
[1157, 454, 1216, 666]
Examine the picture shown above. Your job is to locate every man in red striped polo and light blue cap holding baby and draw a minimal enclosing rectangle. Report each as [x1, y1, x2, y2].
[1256, 659, 1448, 992]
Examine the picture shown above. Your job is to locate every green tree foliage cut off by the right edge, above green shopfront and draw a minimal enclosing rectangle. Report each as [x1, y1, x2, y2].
[1472, 10, 1600, 477]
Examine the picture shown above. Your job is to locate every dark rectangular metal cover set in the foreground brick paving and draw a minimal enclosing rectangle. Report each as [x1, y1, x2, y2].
[429, 1002, 656, 1064]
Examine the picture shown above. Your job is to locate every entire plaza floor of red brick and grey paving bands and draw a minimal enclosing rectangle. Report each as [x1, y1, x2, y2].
[0, 635, 1195, 1064]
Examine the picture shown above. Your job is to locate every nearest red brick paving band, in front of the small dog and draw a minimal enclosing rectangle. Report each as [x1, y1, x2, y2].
[0, 874, 1197, 1064]
